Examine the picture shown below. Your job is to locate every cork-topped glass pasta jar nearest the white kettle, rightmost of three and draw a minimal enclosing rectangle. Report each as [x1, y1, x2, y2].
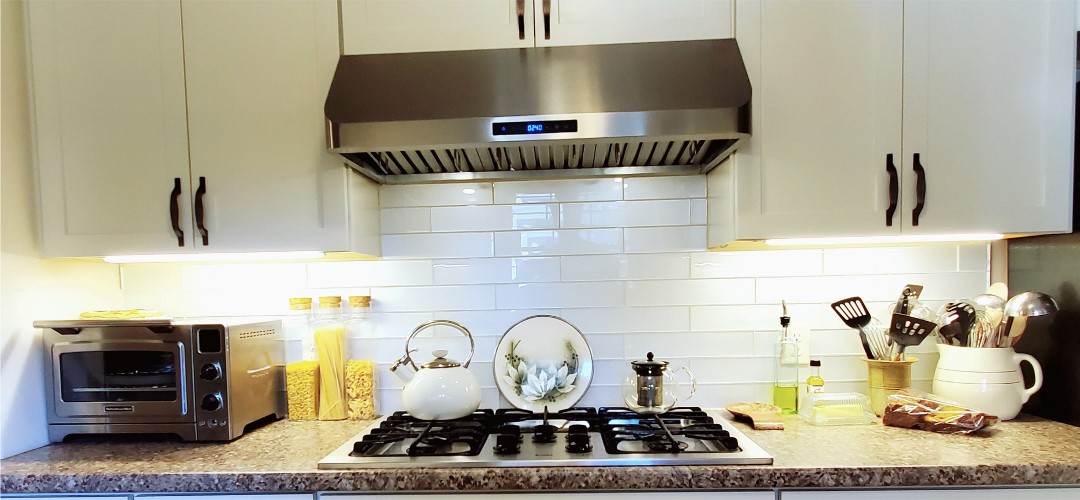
[345, 295, 377, 420]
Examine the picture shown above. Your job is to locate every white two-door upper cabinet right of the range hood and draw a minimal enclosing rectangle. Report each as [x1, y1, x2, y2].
[710, 0, 1076, 245]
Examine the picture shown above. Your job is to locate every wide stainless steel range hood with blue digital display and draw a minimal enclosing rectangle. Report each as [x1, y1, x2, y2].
[326, 39, 751, 184]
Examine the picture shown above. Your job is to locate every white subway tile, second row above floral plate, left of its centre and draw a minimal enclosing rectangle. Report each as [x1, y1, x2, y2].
[432, 257, 559, 285]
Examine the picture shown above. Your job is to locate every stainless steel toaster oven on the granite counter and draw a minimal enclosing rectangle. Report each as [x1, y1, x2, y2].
[33, 319, 287, 443]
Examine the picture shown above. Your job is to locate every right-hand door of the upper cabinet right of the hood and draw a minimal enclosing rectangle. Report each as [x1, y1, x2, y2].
[904, 0, 1076, 233]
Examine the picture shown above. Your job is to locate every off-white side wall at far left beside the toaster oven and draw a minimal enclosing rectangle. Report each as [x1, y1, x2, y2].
[0, 0, 123, 457]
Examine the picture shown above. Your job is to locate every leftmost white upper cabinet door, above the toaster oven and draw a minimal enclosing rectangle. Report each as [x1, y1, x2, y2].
[27, 0, 193, 257]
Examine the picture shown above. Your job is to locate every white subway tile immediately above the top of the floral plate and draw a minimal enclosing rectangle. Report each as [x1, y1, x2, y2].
[492, 282, 624, 309]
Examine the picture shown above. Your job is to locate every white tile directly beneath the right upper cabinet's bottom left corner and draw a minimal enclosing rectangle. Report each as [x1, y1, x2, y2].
[690, 249, 822, 278]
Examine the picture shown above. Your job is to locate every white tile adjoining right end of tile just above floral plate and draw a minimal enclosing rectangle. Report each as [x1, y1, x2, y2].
[626, 279, 754, 306]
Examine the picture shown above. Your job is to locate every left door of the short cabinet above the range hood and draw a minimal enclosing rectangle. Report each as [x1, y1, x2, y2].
[341, 0, 532, 54]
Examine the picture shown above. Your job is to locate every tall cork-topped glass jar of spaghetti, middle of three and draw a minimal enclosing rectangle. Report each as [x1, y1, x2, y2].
[314, 297, 346, 420]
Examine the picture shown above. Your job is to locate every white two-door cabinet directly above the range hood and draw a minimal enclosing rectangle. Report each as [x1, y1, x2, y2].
[341, 0, 732, 54]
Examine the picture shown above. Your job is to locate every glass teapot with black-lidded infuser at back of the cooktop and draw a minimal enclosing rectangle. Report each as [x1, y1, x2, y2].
[623, 352, 698, 414]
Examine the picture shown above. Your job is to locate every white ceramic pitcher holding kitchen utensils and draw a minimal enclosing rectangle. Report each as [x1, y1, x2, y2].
[933, 343, 1042, 420]
